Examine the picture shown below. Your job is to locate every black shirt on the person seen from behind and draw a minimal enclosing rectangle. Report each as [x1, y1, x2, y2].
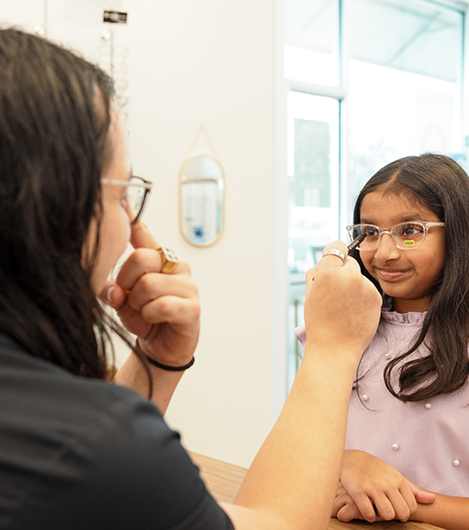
[0, 334, 233, 530]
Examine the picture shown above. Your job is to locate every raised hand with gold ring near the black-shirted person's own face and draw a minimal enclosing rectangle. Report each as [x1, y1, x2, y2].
[101, 221, 200, 366]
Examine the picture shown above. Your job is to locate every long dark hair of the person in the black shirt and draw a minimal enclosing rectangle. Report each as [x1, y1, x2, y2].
[0, 29, 140, 378]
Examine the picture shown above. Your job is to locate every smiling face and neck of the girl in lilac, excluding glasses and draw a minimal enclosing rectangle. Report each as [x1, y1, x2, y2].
[360, 190, 446, 313]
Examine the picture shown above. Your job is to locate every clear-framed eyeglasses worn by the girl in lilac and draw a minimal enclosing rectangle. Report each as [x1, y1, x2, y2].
[347, 221, 445, 250]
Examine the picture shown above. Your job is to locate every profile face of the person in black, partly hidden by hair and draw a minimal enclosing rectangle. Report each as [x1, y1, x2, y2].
[88, 105, 131, 294]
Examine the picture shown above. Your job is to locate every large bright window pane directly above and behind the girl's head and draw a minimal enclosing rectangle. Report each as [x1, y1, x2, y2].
[347, 0, 464, 217]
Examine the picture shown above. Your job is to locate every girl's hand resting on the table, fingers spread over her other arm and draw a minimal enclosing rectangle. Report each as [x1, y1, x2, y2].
[338, 450, 435, 523]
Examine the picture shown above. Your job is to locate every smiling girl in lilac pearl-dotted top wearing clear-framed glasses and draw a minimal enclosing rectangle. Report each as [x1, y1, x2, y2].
[308, 154, 469, 530]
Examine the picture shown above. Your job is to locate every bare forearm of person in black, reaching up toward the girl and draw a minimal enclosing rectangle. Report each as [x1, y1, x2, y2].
[225, 346, 361, 530]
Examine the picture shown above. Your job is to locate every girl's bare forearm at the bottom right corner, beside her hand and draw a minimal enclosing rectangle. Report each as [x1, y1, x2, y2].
[411, 494, 469, 530]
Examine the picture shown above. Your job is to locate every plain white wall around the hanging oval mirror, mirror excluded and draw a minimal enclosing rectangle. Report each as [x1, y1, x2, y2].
[122, 0, 280, 466]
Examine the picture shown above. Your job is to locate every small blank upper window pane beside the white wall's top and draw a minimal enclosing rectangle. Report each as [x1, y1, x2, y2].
[284, 0, 339, 86]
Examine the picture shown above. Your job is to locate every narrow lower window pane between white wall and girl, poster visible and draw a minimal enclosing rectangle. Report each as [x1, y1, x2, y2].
[288, 92, 339, 388]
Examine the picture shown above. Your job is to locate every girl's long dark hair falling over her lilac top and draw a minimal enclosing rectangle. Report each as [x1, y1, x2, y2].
[353, 154, 469, 401]
